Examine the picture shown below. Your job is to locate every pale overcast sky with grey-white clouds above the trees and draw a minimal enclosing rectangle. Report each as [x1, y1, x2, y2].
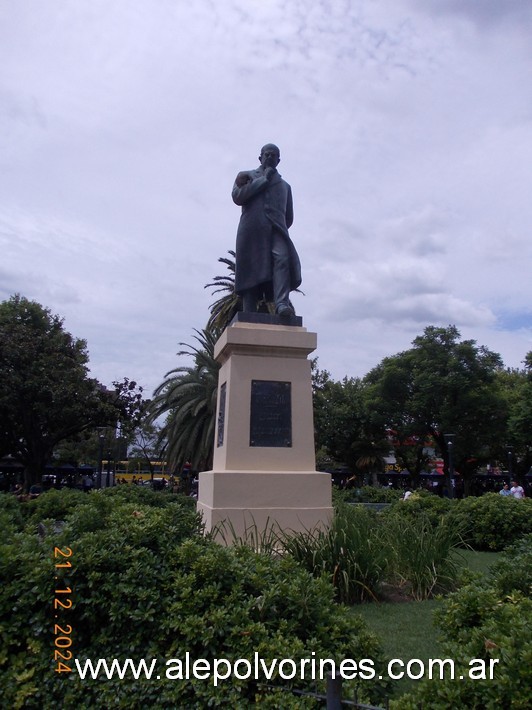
[0, 0, 532, 394]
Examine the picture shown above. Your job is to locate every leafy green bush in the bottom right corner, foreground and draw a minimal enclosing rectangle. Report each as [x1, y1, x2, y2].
[391, 540, 532, 710]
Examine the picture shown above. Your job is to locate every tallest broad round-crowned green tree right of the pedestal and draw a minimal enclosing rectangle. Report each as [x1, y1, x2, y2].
[364, 326, 507, 492]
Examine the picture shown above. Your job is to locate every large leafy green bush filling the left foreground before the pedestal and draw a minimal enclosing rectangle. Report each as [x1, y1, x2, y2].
[0, 491, 381, 710]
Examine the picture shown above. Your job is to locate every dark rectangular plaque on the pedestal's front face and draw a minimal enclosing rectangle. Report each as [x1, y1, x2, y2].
[249, 380, 292, 447]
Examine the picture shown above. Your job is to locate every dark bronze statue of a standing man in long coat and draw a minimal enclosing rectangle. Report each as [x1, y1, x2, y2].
[232, 143, 301, 316]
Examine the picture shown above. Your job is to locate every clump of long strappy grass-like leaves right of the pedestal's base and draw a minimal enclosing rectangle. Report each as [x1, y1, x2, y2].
[283, 501, 468, 604]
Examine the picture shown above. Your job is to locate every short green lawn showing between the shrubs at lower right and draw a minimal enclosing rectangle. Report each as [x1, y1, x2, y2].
[353, 550, 500, 697]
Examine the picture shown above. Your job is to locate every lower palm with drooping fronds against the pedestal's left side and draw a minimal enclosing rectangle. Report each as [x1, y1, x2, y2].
[150, 327, 220, 471]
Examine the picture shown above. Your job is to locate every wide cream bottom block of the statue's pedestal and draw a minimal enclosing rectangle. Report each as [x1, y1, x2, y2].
[198, 471, 333, 544]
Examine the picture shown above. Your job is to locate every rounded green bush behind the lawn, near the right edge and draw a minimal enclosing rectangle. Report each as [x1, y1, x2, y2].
[450, 493, 532, 551]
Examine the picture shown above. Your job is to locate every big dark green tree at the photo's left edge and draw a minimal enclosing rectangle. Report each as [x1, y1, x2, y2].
[0, 294, 136, 487]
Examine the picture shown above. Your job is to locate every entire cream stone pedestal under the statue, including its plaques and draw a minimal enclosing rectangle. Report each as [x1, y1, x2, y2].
[198, 314, 332, 541]
